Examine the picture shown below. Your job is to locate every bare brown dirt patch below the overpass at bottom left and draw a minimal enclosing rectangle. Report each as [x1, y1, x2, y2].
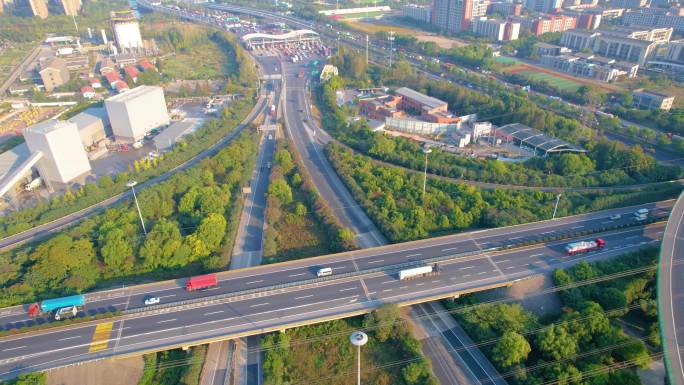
[47, 357, 143, 385]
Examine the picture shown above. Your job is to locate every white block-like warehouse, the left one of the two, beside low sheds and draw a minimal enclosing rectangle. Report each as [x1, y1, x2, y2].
[24, 120, 90, 184]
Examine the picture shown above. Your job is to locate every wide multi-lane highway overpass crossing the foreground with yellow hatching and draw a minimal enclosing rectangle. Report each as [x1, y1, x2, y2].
[0, 201, 673, 379]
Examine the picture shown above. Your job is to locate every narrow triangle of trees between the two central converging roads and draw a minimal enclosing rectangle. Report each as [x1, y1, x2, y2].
[264, 141, 356, 262]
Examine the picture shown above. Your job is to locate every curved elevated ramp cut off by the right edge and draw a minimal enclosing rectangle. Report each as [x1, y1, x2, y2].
[658, 194, 684, 385]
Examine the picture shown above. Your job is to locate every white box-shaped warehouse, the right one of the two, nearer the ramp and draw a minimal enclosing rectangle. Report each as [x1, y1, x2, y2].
[105, 86, 171, 142]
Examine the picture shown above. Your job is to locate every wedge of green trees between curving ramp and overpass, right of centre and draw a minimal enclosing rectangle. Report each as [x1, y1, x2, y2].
[326, 144, 679, 242]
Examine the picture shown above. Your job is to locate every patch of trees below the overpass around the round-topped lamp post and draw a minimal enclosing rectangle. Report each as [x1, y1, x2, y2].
[261, 305, 437, 385]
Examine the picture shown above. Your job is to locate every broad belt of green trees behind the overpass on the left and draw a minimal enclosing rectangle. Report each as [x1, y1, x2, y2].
[0, 130, 256, 306]
